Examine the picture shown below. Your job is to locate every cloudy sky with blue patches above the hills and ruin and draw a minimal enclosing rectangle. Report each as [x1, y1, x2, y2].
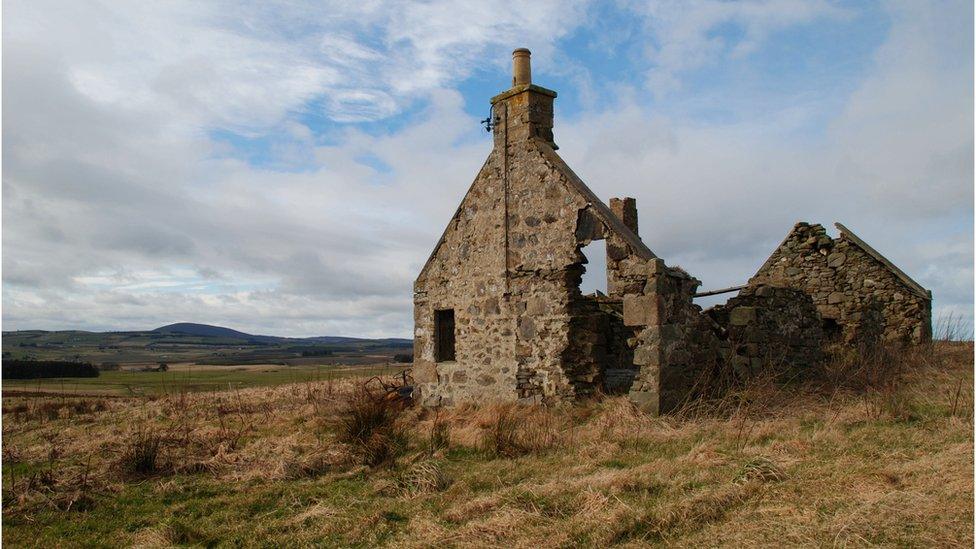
[2, 0, 974, 337]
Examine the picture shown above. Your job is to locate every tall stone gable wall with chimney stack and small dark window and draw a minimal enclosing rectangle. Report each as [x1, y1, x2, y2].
[414, 84, 648, 405]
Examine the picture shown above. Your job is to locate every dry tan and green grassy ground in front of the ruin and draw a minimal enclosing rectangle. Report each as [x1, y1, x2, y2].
[3, 343, 973, 547]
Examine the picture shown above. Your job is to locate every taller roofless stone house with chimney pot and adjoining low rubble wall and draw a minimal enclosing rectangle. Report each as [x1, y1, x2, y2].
[413, 49, 932, 412]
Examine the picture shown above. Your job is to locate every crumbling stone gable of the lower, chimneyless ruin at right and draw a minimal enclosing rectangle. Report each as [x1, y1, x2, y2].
[750, 223, 932, 343]
